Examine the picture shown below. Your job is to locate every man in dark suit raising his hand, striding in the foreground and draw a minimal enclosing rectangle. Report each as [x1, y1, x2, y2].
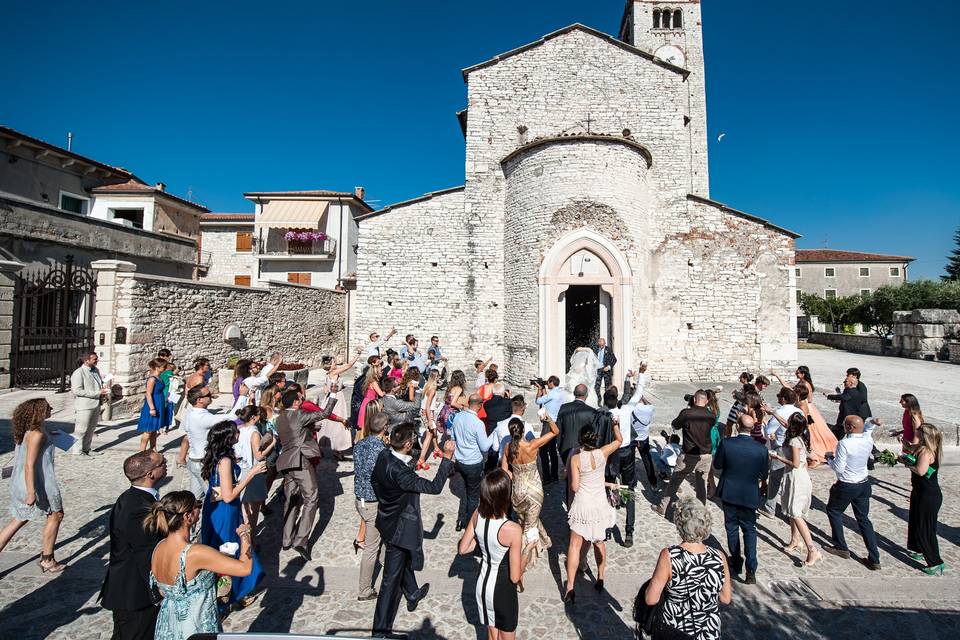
[371, 423, 455, 637]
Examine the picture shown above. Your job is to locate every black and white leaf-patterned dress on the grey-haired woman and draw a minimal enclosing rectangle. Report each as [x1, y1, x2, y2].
[654, 545, 723, 640]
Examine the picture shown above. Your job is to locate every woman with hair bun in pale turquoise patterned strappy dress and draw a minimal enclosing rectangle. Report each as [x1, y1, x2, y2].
[143, 491, 254, 640]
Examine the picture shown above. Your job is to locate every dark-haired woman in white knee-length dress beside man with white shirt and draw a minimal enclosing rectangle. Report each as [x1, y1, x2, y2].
[770, 413, 822, 567]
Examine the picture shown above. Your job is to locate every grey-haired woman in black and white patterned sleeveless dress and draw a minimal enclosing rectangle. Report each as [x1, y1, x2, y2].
[645, 495, 731, 640]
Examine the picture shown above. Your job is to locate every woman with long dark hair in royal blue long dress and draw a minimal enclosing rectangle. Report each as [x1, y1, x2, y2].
[200, 420, 267, 608]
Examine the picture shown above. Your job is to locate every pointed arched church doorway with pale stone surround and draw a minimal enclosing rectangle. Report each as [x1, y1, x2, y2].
[539, 229, 633, 384]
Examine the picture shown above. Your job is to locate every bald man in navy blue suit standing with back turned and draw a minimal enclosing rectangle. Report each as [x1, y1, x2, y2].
[713, 414, 770, 584]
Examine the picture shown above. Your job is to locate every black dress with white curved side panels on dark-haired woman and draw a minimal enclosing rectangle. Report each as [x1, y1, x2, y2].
[474, 515, 519, 632]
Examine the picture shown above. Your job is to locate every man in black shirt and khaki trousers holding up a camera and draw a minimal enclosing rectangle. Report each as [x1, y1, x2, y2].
[650, 389, 715, 516]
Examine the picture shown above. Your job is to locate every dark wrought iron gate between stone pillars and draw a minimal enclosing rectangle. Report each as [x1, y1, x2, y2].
[11, 256, 97, 392]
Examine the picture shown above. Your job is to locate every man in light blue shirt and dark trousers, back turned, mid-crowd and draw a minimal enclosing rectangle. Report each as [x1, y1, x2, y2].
[451, 393, 495, 531]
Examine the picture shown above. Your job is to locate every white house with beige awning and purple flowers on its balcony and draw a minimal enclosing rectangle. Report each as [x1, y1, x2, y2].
[244, 187, 373, 289]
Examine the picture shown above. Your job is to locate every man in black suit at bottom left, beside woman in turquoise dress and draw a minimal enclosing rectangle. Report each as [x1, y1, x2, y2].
[100, 451, 167, 640]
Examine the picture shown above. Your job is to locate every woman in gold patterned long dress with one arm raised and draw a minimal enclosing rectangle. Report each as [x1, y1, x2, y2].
[501, 414, 560, 576]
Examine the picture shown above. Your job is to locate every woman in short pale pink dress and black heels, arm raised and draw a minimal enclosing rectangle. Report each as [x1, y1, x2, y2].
[563, 422, 623, 606]
